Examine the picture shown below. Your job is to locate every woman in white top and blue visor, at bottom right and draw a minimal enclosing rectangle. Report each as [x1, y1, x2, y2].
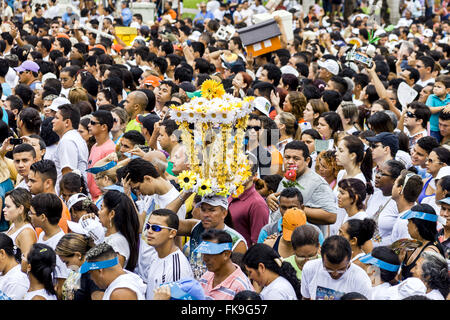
[360, 246, 400, 300]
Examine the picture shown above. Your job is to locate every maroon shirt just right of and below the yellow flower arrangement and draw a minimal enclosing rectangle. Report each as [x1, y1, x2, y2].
[228, 185, 269, 248]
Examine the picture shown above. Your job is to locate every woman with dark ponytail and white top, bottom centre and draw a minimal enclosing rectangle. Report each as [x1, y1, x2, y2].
[242, 243, 301, 300]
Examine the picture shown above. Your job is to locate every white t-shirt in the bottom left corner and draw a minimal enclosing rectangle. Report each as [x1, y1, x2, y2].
[0, 264, 30, 300]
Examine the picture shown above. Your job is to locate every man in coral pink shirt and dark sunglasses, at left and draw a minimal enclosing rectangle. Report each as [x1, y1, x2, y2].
[87, 110, 116, 201]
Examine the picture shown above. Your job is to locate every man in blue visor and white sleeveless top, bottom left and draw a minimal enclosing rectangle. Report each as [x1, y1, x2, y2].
[80, 242, 147, 300]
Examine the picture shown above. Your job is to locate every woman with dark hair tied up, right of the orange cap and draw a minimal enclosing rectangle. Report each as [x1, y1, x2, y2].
[339, 218, 376, 269]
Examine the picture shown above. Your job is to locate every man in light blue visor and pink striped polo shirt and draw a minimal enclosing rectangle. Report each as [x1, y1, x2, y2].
[195, 229, 255, 300]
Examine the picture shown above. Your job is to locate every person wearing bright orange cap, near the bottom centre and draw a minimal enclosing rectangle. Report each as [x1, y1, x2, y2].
[264, 208, 306, 258]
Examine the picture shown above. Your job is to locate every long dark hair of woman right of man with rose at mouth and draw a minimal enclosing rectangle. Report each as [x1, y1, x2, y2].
[343, 135, 374, 194]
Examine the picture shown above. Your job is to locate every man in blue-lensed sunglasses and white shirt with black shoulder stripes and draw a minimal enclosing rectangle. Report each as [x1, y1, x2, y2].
[145, 209, 193, 300]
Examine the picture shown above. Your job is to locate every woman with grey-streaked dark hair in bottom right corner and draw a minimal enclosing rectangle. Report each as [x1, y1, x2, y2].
[411, 251, 450, 300]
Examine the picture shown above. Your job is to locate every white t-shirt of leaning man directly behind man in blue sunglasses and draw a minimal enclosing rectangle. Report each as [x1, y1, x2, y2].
[134, 186, 186, 282]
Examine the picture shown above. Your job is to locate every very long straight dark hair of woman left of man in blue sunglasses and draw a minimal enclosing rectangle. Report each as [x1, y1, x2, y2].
[103, 190, 139, 271]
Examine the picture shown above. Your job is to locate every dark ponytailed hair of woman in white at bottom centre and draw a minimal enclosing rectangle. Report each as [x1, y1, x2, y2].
[243, 243, 302, 299]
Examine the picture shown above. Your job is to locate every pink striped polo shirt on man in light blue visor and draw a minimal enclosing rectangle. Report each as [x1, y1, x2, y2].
[199, 263, 255, 300]
